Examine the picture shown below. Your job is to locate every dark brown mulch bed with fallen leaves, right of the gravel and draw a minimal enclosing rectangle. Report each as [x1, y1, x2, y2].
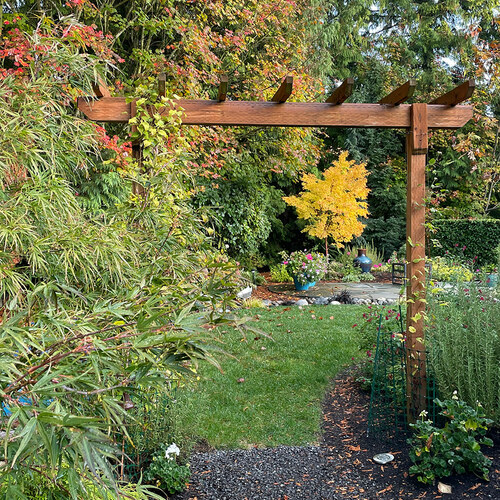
[323, 373, 500, 499]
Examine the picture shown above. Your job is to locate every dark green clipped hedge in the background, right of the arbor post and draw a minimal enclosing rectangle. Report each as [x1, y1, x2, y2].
[430, 219, 500, 266]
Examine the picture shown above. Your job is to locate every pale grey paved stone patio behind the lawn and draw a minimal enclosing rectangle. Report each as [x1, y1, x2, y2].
[268, 283, 402, 301]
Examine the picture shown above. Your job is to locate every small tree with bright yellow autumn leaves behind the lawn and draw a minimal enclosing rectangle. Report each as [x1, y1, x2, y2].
[283, 151, 369, 258]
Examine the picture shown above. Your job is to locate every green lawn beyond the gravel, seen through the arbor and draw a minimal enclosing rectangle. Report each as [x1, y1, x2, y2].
[176, 306, 366, 448]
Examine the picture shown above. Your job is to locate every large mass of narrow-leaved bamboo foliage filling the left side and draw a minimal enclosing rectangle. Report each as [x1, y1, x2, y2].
[0, 18, 242, 499]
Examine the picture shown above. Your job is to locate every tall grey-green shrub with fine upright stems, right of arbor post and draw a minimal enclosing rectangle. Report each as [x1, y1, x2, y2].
[426, 282, 500, 423]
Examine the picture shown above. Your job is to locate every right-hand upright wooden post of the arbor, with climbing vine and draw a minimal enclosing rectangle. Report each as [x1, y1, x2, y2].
[406, 104, 428, 422]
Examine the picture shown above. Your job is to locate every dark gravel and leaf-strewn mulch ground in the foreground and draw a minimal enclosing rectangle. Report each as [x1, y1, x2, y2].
[174, 371, 500, 500]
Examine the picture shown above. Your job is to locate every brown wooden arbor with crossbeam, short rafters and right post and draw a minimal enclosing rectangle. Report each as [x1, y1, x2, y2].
[78, 76, 474, 420]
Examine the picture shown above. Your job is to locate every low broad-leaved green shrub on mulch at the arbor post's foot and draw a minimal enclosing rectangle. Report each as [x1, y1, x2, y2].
[408, 394, 493, 484]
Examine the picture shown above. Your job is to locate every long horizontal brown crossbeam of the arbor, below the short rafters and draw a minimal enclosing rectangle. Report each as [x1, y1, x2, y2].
[78, 97, 472, 129]
